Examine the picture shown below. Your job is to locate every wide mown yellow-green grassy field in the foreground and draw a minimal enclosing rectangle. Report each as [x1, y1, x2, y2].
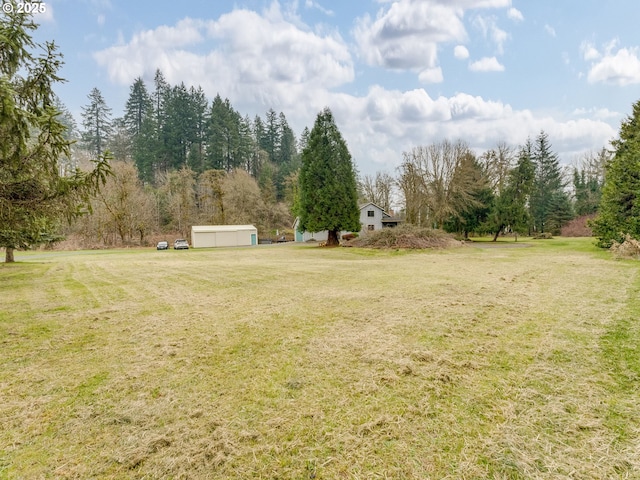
[0, 239, 640, 479]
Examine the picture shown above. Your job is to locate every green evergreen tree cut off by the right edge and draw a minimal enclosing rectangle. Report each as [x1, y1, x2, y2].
[591, 101, 640, 248]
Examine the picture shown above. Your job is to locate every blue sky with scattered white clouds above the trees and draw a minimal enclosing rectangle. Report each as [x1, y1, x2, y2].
[25, 0, 640, 175]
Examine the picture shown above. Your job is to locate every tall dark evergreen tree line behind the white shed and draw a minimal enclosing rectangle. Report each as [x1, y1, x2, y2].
[76, 70, 308, 201]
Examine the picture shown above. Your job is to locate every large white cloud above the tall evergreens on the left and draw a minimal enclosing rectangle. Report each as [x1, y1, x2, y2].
[94, 4, 354, 97]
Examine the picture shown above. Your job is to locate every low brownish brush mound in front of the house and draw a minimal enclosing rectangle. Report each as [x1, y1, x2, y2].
[344, 225, 462, 249]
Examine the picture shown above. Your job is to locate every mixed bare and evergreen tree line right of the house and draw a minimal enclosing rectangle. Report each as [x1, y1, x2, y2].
[396, 131, 610, 240]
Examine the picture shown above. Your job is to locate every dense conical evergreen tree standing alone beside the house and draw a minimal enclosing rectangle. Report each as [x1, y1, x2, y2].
[297, 108, 360, 245]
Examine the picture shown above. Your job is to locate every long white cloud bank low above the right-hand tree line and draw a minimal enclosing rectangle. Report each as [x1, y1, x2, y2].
[330, 86, 616, 173]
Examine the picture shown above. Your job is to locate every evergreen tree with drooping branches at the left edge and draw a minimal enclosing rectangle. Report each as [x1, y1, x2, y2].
[0, 6, 109, 262]
